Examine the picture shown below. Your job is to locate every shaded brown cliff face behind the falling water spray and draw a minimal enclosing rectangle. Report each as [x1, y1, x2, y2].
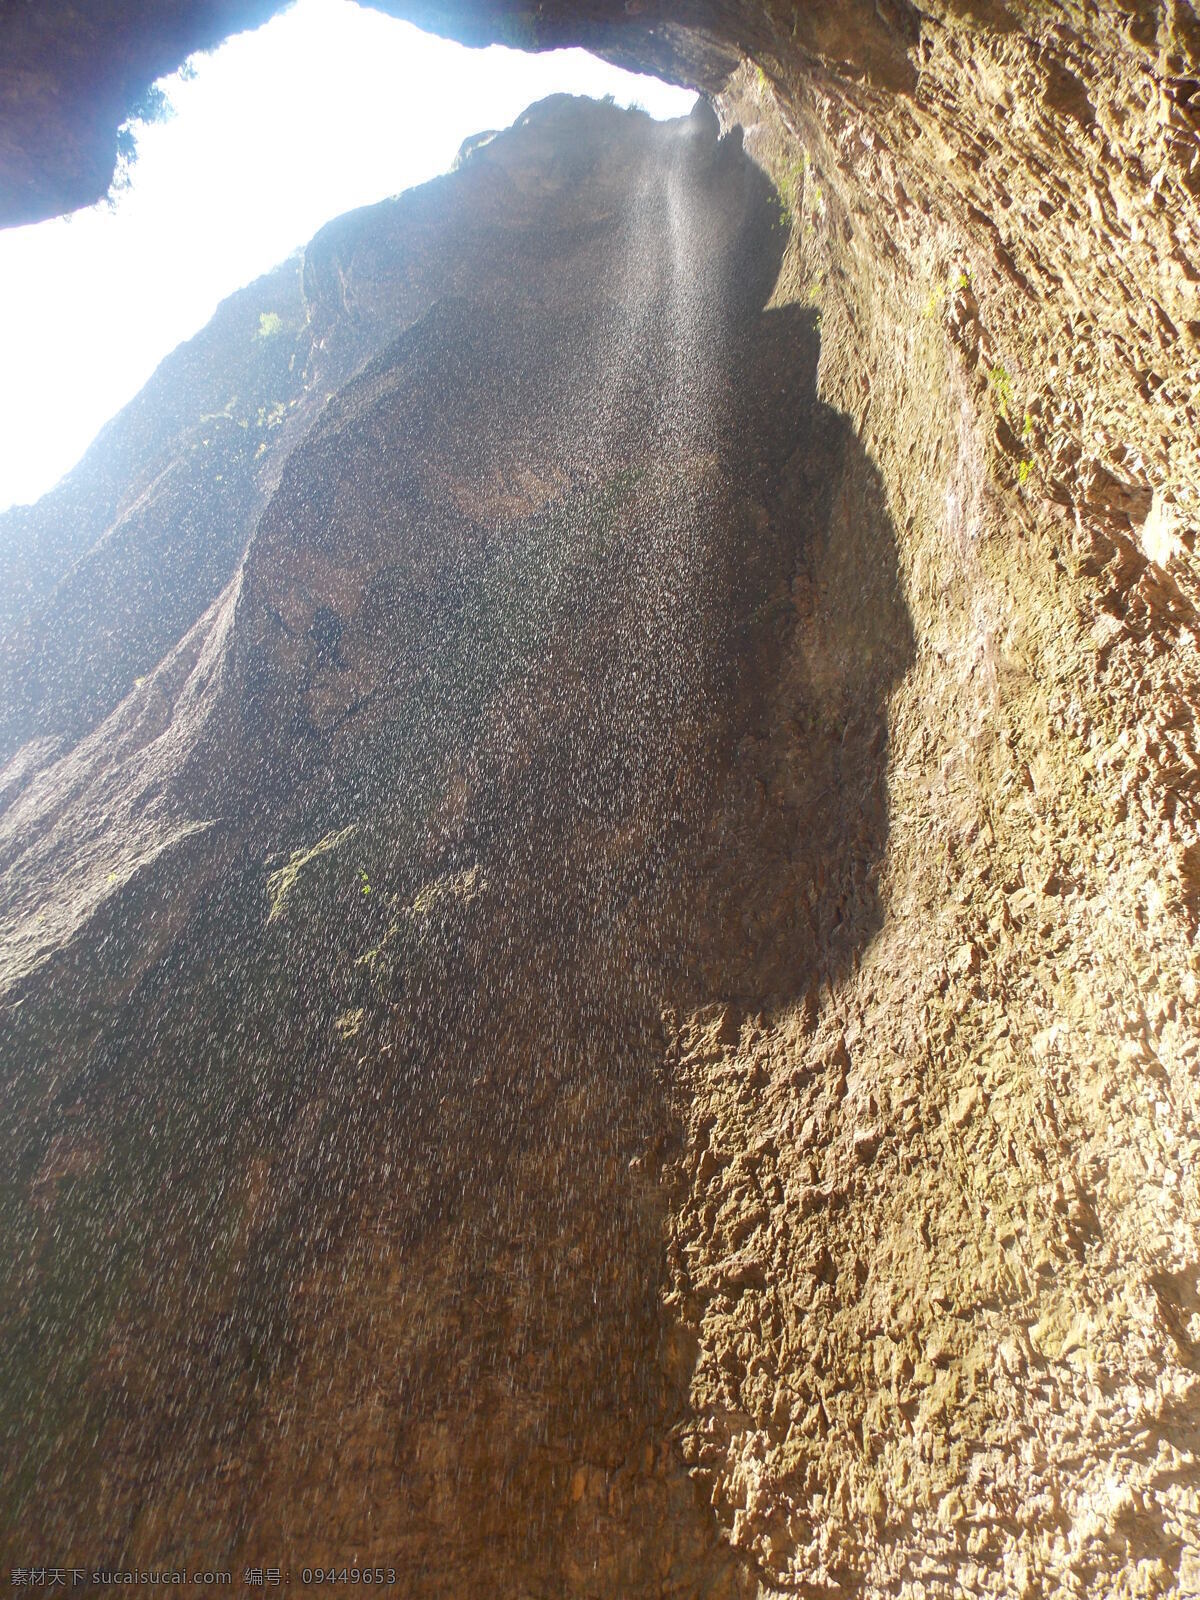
[0, 99, 910, 1594]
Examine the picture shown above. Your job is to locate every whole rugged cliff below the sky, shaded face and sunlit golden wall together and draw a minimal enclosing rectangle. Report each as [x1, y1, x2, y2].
[0, 0, 1200, 1597]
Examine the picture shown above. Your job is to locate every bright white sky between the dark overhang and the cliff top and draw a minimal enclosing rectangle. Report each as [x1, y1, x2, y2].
[0, 0, 694, 509]
